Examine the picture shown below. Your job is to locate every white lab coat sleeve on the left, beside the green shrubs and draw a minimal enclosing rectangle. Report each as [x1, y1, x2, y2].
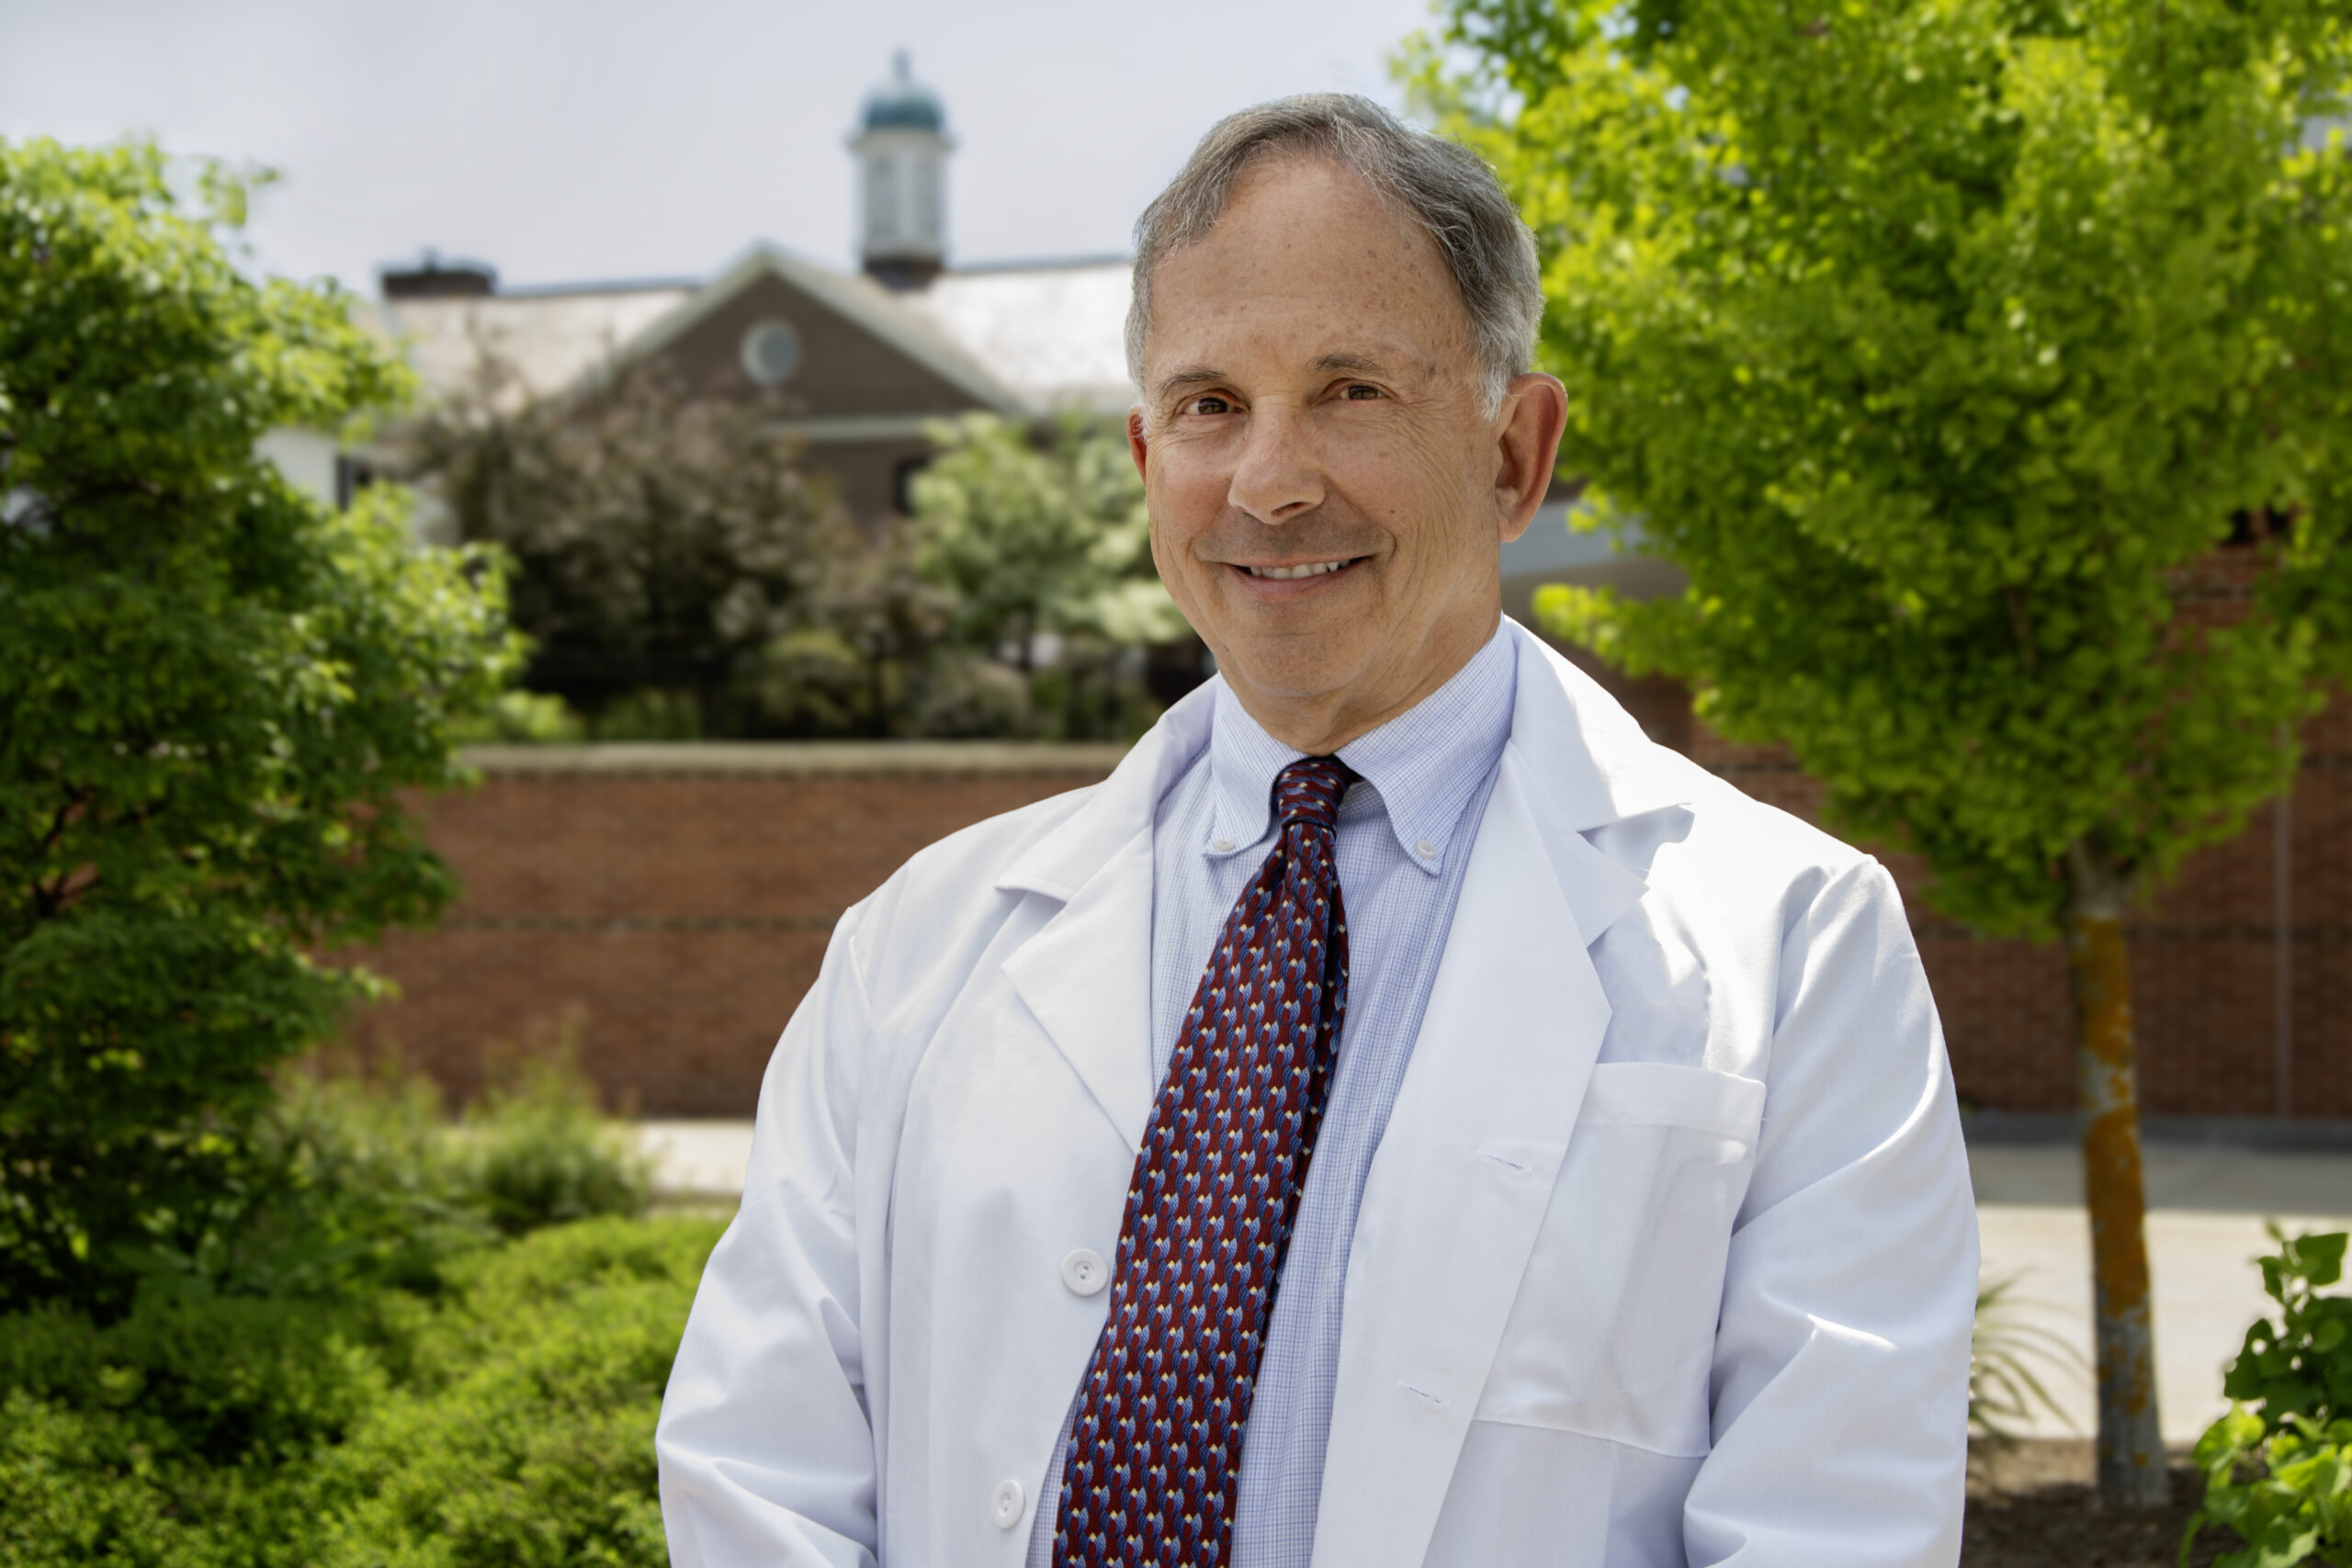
[654, 905, 877, 1568]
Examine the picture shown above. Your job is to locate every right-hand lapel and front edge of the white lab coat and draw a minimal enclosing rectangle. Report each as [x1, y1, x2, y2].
[1315, 635, 1646, 1568]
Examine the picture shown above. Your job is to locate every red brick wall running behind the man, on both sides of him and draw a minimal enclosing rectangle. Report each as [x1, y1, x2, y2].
[353, 689, 2352, 1117]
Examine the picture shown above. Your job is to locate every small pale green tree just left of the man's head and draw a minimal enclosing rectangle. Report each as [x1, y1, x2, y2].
[915, 413, 1185, 733]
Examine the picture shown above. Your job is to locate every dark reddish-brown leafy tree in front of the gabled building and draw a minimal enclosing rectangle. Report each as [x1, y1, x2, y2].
[402, 353, 865, 739]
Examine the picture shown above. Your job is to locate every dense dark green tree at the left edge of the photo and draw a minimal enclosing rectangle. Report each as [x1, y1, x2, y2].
[0, 141, 511, 1312]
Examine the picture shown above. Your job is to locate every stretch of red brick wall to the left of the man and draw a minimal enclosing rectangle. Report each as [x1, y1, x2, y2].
[336, 743, 1120, 1117]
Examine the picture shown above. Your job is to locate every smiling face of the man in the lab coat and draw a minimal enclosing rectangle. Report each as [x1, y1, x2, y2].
[1129, 157, 1559, 750]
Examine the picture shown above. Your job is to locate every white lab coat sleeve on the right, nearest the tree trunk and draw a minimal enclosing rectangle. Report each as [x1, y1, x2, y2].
[1684, 861, 1975, 1568]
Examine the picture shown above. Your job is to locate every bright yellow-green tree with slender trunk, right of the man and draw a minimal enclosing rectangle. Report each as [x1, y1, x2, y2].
[1411, 0, 2352, 1505]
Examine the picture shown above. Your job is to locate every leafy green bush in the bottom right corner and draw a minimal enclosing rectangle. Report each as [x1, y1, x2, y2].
[2180, 1224, 2352, 1568]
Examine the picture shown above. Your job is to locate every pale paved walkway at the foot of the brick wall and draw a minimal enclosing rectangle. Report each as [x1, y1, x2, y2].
[638, 1122, 2352, 1441]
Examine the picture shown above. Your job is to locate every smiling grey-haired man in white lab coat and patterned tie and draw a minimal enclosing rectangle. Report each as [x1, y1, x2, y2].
[659, 96, 1975, 1568]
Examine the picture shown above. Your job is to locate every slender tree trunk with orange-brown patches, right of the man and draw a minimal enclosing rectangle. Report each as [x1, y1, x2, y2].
[2065, 844, 2168, 1509]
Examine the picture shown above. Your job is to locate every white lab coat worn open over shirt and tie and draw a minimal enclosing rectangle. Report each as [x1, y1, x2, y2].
[659, 627, 1975, 1568]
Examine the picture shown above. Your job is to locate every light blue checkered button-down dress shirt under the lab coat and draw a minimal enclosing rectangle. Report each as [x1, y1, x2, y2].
[1028, 627, 1517, 1568]
